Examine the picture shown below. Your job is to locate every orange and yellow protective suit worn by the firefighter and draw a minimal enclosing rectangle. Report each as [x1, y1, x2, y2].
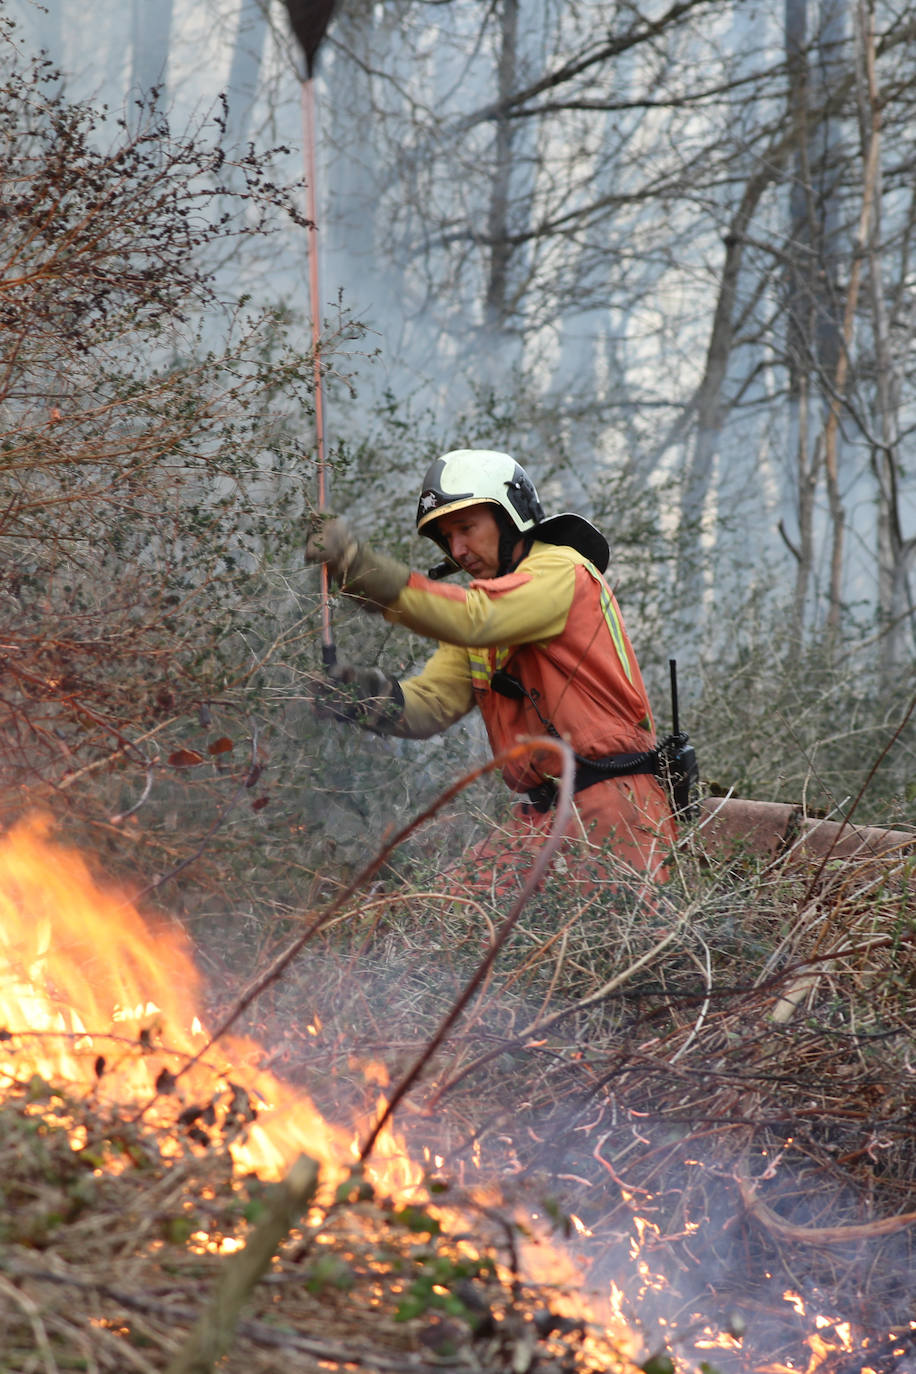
[385, 543, 674, 877]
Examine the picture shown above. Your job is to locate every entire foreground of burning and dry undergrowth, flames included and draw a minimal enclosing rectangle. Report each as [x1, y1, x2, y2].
[0, 802, 916, 1374]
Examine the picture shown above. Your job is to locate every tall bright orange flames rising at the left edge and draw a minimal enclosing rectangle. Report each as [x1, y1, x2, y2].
[0, 818, 423, 1195]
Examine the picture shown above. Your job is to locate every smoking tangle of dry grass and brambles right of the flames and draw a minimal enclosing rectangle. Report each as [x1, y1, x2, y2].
[215, 813, 916, 1370]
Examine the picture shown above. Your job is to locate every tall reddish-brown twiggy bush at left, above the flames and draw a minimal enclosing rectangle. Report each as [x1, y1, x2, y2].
[0, 21, 336, 870]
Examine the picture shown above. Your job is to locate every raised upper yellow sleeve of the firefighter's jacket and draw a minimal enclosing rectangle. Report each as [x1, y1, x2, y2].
[385, 543, 577, 648]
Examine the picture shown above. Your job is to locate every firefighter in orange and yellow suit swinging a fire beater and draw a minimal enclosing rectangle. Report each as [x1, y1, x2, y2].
[306, 449, 674, 881]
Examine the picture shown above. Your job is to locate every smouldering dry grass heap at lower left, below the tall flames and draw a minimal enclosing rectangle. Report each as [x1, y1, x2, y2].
[0, 1080, 645, 1374]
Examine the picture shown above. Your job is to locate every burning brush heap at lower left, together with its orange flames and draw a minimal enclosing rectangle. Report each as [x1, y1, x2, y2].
[0, 824, 645, 1374]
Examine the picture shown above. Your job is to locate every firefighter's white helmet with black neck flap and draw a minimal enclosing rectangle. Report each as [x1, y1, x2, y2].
[416, 448, 611, 573]
